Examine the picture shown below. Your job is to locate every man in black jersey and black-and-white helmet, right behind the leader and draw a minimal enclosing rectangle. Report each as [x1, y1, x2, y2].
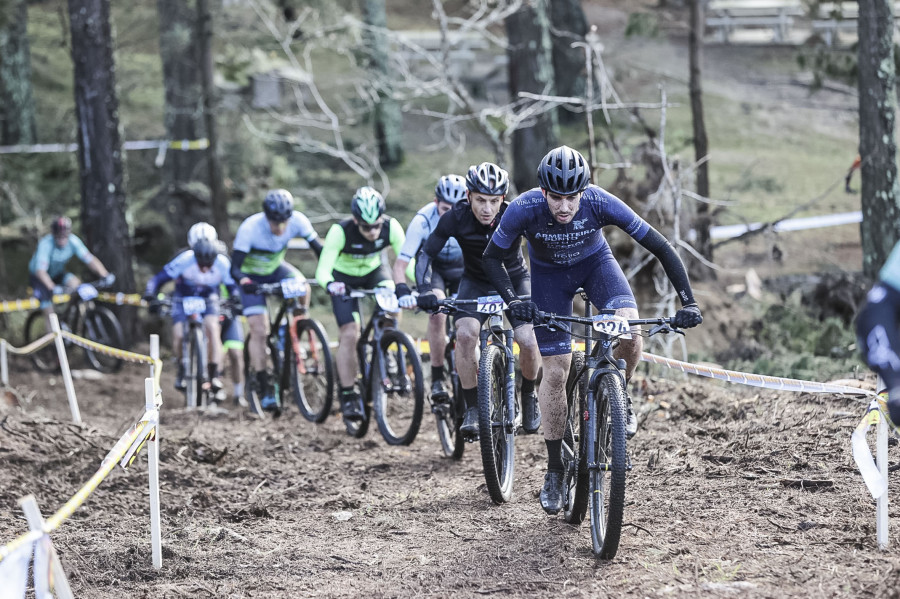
[416, 162, 541, 438]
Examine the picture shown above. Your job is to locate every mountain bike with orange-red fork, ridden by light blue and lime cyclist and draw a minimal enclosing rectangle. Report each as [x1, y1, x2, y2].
[244, 277, 334, 423]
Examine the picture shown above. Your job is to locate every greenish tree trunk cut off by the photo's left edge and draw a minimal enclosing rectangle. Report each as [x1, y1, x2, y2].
[0, 0, 37, 145]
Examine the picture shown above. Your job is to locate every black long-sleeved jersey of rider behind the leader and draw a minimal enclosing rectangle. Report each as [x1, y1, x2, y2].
[416, 200, 527, 293]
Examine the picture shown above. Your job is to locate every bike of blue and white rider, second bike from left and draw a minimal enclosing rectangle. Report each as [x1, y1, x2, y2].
[150, 296, 230, 408]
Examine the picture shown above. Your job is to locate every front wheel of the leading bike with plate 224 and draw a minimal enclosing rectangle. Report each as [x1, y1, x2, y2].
[588, 373, 627, 559]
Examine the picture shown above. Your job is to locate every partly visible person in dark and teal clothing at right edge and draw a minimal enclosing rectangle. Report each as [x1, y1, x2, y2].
[856, 243, 900, 431]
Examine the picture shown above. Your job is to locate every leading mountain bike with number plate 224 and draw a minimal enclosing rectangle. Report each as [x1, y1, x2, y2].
[535, 310, 683, 559]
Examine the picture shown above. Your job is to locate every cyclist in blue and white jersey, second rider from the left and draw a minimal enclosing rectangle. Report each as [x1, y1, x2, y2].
[144, 229, 237, 401]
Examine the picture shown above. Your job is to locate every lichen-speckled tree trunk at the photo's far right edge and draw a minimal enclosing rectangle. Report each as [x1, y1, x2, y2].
[857, 0, 900, 278]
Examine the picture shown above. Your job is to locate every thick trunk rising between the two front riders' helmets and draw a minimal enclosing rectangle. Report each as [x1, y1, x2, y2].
[506, 0, 559, 192]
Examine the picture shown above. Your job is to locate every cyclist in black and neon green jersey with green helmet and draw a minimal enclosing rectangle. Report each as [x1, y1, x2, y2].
[316, 187, 405, 420]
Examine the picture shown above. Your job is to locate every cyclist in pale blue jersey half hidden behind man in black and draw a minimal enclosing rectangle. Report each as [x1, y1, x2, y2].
[394, 175, 467, 401]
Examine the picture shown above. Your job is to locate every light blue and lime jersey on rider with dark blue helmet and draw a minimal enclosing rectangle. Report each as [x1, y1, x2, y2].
[231, 210, 317, 279]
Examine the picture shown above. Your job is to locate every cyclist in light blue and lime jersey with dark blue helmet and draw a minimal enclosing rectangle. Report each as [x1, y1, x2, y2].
[231, 189, 322, 413]
